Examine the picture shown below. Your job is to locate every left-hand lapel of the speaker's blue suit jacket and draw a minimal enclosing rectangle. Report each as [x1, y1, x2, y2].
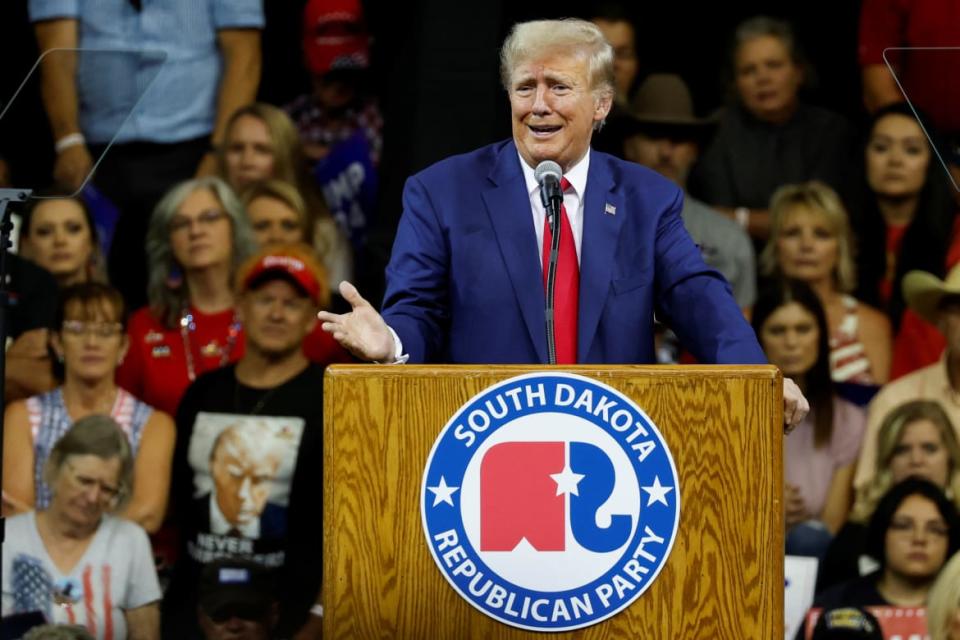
[482, 142, 547, 362]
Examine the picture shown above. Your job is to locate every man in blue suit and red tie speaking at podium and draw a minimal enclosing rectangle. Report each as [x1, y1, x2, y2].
[320, 20, 807, 425]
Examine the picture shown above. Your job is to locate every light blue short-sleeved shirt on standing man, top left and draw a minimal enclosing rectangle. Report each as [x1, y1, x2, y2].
[29, 0, 263, 144]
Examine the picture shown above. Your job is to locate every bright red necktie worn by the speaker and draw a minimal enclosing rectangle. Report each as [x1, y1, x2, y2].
[543, 178, 580, 364]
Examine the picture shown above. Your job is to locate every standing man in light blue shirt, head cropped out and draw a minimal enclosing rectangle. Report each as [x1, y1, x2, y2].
[29, 0, 263, 309]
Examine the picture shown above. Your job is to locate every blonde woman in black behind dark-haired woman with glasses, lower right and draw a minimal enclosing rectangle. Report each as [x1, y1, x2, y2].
[817, 400, 960, 590]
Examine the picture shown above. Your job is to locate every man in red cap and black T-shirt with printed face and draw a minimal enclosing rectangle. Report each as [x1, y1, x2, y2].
[164, 245, 329, 637]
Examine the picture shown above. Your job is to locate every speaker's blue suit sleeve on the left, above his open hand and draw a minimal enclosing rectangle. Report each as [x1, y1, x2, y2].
[383, 176, 450, 363]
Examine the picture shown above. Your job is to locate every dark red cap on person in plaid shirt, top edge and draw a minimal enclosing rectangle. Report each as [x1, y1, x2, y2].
[303, 0, 370, 75]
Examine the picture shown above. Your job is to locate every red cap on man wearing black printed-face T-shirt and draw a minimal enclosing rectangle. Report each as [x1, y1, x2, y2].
[236, 243, 330, 306]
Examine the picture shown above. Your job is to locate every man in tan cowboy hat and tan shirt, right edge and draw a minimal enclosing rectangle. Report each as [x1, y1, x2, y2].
[853, 265, 960, 489]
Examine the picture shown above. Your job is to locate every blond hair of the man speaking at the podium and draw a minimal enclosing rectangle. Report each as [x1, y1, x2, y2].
[500, 18, 616, 129]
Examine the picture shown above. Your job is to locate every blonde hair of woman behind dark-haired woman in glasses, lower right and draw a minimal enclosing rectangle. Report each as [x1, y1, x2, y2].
[850, 400, 960, 523]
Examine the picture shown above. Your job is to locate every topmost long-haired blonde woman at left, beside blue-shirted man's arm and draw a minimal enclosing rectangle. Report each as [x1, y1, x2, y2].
[218, 103, 353, 291]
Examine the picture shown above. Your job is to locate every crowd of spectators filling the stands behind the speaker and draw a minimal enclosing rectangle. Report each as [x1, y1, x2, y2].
[2, 0, 960, 640]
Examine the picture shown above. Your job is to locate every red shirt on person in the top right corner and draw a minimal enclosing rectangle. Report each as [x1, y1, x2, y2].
[859, 0, 960, 133]
